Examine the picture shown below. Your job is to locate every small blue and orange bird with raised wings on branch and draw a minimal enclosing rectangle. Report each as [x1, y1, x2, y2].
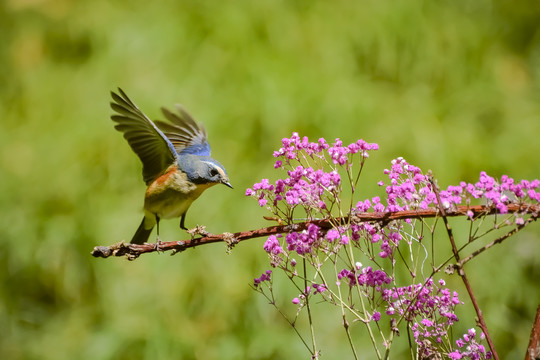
[111, 88, 232, 244]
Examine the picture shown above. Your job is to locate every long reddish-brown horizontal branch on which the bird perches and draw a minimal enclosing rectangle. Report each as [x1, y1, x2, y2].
[91, 204, 540, 260]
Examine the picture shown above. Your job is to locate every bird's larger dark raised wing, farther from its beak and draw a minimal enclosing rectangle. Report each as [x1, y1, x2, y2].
[111, 88, 177, 184]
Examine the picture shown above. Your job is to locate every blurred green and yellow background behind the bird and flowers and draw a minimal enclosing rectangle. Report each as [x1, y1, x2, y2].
[0, 0, 540, 359]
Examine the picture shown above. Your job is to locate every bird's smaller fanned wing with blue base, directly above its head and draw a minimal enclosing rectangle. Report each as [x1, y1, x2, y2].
[156, 105, 210, 156]
